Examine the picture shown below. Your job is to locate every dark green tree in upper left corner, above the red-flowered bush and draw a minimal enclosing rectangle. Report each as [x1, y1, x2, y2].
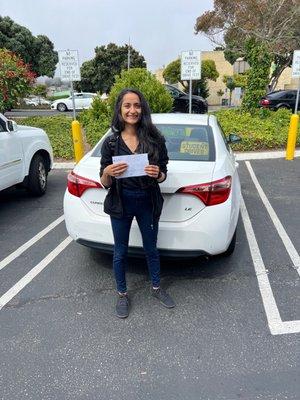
[0, 16, 58, 77]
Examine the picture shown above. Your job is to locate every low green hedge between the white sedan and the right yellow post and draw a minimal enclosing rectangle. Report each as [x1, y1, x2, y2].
[212, 109, 300, 151]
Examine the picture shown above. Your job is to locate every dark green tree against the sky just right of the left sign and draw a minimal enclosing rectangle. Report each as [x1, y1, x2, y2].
[75, 43, 146, 93]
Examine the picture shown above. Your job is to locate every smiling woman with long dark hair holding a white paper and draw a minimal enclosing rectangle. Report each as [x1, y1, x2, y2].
[100, 89, 175, 318]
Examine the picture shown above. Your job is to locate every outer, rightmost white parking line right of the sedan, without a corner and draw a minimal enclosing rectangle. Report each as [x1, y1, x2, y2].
[245, 161, 300, 275]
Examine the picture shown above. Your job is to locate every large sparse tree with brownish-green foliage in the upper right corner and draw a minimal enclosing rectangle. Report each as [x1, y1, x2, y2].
[195, 0, 300, 90]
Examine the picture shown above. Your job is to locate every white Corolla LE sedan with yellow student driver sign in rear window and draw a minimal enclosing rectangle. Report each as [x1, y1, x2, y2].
[64, 114, 241, 257]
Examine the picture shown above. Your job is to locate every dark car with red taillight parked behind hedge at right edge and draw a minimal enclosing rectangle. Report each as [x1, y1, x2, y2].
[259, 90, 300, 111]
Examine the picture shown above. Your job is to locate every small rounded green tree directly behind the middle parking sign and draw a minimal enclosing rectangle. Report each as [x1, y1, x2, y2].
[163, 58, 219, 98]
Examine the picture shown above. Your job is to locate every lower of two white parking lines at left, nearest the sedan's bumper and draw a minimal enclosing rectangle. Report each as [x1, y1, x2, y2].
[0, 236, 73, 310]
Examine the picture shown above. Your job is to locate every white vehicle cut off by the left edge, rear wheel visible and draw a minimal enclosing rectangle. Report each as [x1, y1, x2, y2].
[0, 114, 53, 196]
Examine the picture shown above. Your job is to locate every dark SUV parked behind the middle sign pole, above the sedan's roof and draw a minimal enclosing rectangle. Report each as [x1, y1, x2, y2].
[165, 85, 208, 114]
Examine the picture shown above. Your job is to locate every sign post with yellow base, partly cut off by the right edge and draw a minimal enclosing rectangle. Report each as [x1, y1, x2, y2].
[285, 50, 300, 160]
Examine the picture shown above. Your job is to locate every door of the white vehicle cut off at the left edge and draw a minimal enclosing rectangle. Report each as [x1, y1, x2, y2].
[0, 119, 23, 190]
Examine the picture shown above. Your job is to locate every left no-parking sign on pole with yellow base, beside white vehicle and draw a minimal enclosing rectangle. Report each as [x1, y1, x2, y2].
[58, 50, 84, 163]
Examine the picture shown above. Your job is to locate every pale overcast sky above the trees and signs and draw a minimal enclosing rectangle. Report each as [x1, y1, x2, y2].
[0, 0, 214, 72]
